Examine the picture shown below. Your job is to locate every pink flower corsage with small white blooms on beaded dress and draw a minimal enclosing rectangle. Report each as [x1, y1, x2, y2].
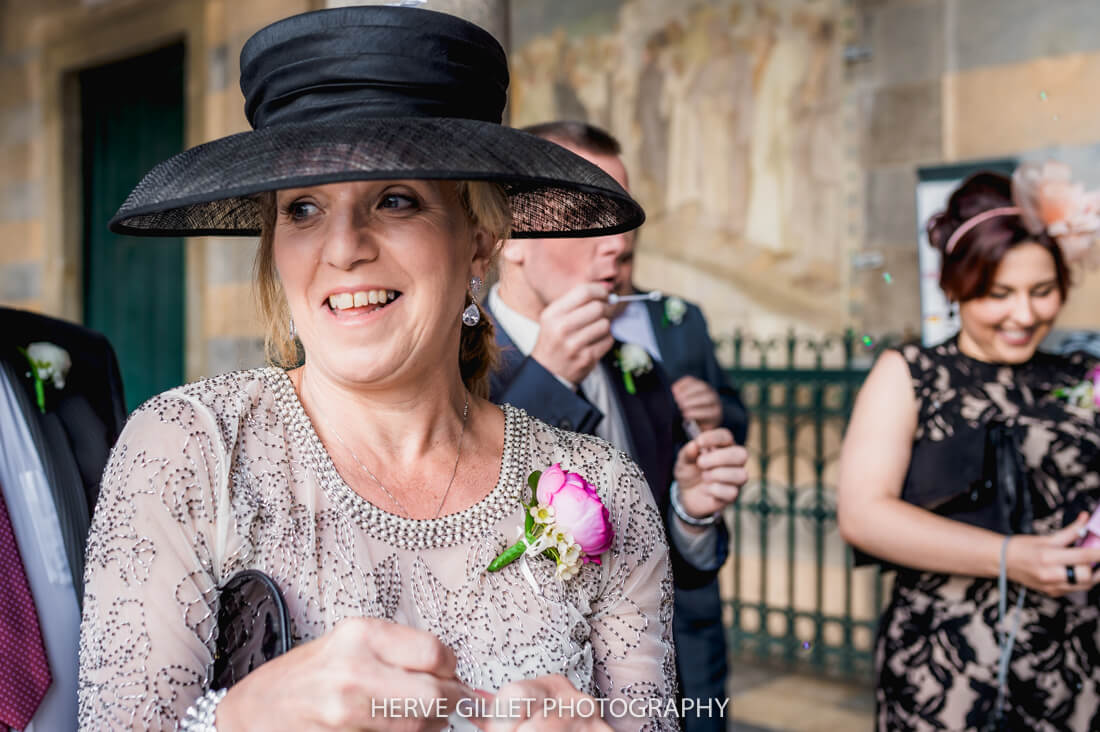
[487, 462, 615, 579]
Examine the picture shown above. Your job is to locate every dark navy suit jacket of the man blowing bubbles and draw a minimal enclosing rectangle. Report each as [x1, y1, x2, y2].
[486, 303, 728, 589]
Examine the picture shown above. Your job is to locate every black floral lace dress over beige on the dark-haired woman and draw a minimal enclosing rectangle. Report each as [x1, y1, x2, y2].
[876, 339, 1100, 732]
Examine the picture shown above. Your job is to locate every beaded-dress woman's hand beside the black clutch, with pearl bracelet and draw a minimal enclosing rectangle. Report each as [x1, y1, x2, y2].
[217, 618, 474, 732]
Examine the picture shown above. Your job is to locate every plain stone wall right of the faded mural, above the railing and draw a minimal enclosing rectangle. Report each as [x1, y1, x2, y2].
[848, 0, 1100, 332]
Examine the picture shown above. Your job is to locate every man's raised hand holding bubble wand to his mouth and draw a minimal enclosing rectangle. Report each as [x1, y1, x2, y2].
[531, 283, 615, 385]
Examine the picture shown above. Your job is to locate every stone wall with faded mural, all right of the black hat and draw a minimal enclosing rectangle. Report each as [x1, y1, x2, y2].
[512, 0, 1100, 343]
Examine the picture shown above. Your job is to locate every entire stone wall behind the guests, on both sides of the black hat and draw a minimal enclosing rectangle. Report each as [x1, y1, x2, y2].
[0, 0, 1100, 379]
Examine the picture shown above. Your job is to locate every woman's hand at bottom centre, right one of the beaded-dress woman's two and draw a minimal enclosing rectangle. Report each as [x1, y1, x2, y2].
[472, 676, 612, 732]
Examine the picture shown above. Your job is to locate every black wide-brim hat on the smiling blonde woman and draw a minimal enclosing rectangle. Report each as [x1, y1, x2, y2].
[110, 6, 645, 238]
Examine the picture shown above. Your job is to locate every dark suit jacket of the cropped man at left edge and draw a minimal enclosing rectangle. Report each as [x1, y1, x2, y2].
[0, 307, 127, 599]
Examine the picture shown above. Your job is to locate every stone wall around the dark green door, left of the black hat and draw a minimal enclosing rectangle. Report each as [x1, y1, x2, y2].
[0, 0, 508, 379]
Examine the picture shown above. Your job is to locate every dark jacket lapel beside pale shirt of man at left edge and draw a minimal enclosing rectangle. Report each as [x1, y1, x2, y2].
[0, 348, 90, 602]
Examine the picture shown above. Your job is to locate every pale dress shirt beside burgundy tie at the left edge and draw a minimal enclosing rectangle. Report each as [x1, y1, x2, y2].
[0, 371, 80, 732]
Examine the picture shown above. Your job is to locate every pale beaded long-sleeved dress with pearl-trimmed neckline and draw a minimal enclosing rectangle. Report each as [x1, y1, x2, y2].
[79, 368, 677, 730]
